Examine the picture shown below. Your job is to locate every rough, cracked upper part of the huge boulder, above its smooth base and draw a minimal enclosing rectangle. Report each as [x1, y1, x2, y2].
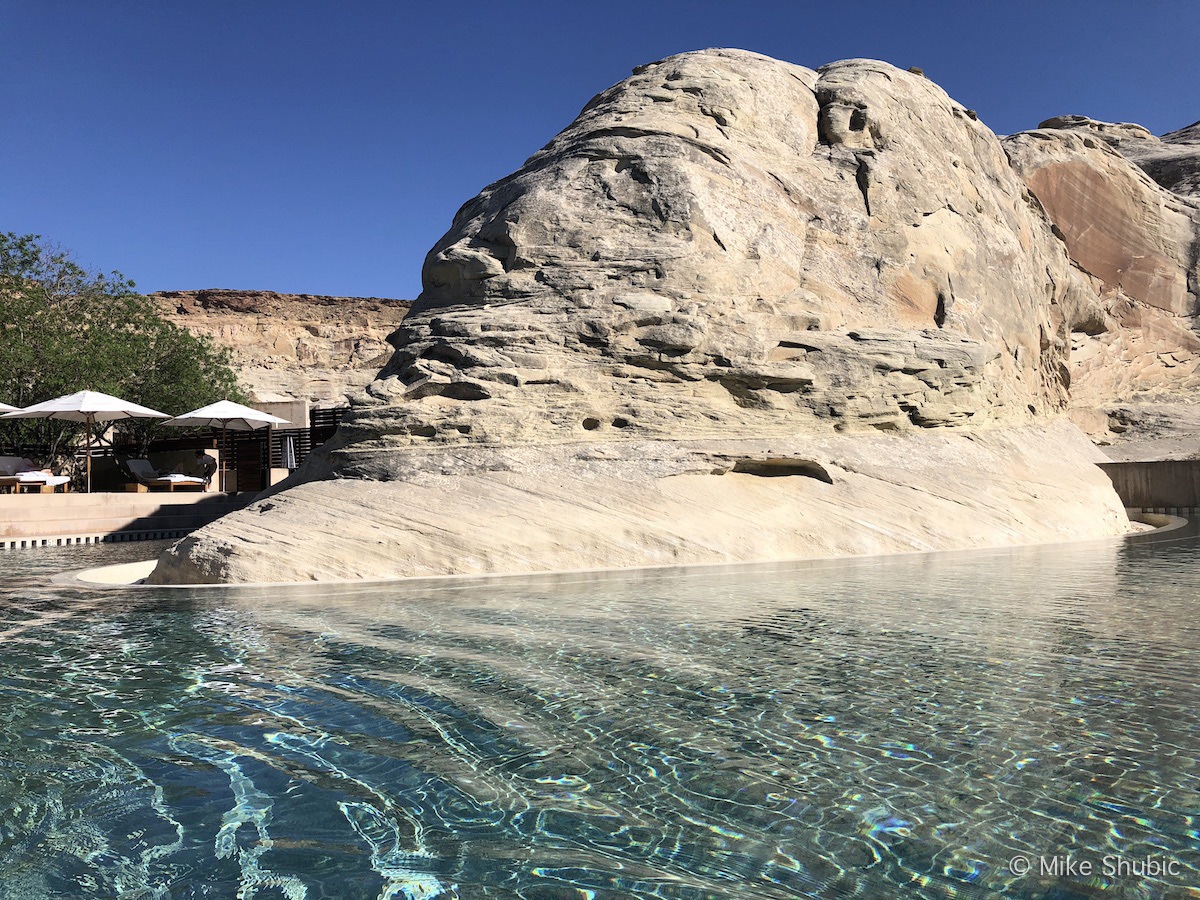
[357, 52, 1090, 449]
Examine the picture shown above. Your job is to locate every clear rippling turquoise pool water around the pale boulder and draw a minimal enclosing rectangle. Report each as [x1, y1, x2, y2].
[0, 530, 1200, 900]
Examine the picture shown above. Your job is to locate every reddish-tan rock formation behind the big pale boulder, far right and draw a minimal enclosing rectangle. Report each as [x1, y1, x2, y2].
[1003, 116, 1200, 457]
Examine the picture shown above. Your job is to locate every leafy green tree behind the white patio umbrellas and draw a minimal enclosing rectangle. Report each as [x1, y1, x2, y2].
[0, 232, 245, 468]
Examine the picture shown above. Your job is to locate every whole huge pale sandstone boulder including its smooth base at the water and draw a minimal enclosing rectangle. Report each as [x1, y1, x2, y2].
[154, 50, 1132, 582]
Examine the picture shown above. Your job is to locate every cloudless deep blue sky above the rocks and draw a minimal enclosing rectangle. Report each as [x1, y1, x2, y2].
[0, 0, 1200, 298]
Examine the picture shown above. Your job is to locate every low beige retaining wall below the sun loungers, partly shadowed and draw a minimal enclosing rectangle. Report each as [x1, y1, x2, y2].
[0, 492, 254, 550]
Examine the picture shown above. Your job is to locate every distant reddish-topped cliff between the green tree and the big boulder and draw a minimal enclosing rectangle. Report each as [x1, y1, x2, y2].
[151, 289, 410, 406]
